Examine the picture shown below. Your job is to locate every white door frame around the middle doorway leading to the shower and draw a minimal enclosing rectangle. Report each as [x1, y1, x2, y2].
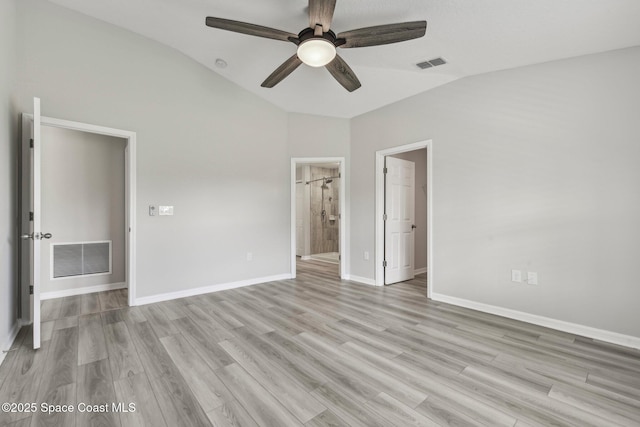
[291, 157, 349, 279]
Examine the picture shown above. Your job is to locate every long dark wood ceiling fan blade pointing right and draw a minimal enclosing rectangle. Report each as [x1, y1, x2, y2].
[338, 21, 427, 48]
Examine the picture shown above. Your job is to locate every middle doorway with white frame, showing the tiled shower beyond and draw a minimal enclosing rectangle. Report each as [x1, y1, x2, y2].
[291, 157, 346, 278]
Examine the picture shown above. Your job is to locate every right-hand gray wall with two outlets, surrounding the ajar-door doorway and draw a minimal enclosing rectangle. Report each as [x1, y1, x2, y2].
[351, 48, 640, 337]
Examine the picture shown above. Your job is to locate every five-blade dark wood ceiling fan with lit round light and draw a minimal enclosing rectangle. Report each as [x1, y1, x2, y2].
[206, 0, 427, 92]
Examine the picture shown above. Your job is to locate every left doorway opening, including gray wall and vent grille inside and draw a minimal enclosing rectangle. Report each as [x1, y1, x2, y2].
[40, 126, 126, 300]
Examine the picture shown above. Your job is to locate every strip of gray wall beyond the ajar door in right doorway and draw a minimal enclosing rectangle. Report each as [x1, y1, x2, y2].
[389, 148, 427, 270]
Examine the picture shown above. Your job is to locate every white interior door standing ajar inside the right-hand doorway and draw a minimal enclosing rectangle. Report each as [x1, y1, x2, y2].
[384, 157, 416, 285]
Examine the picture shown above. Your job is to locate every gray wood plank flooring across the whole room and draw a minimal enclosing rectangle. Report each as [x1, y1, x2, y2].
[0, 261, 640, 427]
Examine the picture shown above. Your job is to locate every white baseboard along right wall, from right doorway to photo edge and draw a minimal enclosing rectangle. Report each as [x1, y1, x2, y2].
[431, 293, 640, 349]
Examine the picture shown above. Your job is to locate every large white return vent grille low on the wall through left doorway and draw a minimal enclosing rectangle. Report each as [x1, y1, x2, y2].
[51, 241, 111, 279]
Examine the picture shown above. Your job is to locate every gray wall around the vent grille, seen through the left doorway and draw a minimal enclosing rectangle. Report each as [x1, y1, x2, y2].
[40, 126, 126, 292]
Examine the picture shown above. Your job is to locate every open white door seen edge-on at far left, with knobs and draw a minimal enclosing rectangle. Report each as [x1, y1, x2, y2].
[21, 98, 51, 349]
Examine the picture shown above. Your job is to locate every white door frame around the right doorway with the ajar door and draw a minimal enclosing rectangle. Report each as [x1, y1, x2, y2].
[375, 139, 434, 298]
